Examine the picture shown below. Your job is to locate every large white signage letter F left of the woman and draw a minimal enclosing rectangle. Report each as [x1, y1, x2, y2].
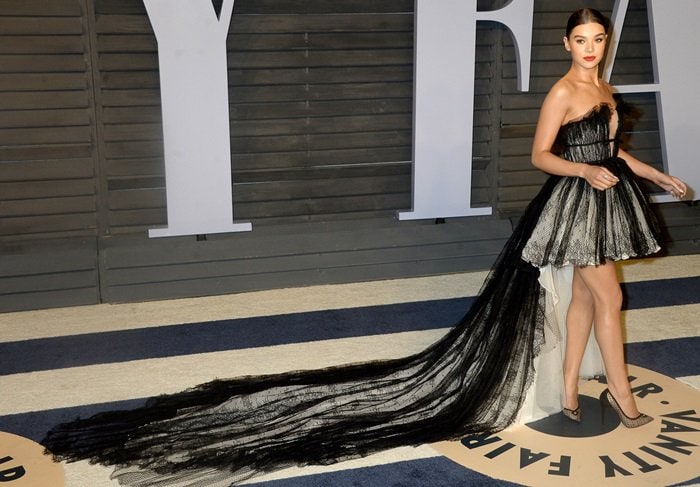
[399, 0, 534, 220]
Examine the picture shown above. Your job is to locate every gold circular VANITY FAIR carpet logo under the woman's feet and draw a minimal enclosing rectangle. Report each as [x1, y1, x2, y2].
[431, 366, 700, 487]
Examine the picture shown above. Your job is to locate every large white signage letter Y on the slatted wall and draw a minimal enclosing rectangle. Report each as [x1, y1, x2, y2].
[144, 0, 251, 237]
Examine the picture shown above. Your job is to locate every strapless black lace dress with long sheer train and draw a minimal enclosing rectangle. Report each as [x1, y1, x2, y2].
[43, 105, 658, 487]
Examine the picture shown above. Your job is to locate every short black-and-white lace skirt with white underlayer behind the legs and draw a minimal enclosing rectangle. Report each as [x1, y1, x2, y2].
[518, 158, 659, 423]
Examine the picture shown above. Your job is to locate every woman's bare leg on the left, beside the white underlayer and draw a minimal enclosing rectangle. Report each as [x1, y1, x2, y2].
[564, 267, 593, 410]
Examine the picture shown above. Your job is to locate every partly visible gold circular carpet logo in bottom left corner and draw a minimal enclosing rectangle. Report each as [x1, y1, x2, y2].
[0, 431, 65, 487]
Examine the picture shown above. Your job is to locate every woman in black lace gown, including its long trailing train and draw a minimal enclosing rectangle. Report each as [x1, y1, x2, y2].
[44, 11, 685, 487]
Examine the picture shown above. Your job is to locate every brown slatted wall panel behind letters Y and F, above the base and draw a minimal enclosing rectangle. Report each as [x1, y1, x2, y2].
[96, 0, 498, 235]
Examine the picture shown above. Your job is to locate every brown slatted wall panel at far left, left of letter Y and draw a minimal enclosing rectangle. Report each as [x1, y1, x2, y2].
[0, 0, 98, 310]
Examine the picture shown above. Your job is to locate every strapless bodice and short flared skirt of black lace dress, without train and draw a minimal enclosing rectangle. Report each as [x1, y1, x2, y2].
[522, 103, 659, 267]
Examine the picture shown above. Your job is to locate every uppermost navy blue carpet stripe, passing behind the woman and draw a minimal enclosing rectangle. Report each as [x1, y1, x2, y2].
[0, 277, 700, 375]
